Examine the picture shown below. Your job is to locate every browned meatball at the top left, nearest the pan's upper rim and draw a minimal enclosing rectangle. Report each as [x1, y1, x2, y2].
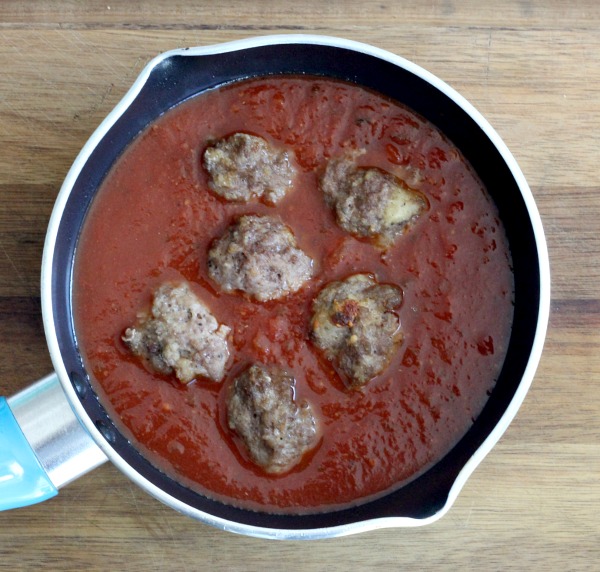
[204, 133, 295, 204]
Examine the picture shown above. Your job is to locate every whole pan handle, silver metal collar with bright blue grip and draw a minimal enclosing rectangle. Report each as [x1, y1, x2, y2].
[0, 373, 107, 510]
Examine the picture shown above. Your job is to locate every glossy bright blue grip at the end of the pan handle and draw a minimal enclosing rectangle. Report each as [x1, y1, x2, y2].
[0, 397, 58, 510]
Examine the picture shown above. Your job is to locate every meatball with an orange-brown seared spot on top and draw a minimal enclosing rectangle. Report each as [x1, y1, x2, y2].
[311, 274, 402, 389]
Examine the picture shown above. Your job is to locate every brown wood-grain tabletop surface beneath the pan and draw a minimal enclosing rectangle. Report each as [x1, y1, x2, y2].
[0, 0, 600, 570]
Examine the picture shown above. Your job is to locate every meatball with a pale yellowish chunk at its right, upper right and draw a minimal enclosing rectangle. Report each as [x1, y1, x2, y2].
[320, 153, 428, 247]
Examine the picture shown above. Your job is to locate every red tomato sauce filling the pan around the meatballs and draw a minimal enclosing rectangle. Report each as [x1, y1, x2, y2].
[73, 77, 513, 512]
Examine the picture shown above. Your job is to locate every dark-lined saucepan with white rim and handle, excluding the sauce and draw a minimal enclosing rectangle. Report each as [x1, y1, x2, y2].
[0, 35, 550, 539]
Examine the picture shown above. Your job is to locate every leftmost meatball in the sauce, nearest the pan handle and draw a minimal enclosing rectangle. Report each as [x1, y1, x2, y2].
[122, 283, 230, 383]
